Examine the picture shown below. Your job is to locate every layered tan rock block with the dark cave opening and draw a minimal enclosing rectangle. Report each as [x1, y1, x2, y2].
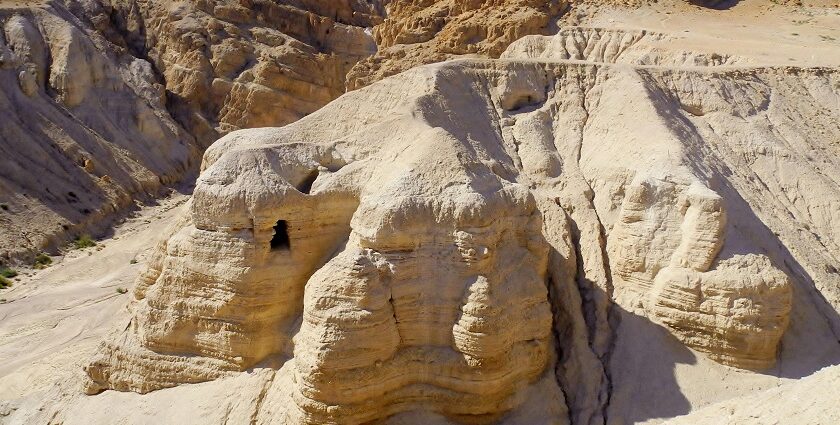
[87, 61, 584, 423]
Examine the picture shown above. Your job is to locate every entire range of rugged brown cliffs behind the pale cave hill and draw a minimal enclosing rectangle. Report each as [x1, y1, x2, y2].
[0, 0, 584, 262]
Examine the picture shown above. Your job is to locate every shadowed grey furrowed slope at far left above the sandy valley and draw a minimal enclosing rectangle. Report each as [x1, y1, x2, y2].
[0, 3, 199, 263]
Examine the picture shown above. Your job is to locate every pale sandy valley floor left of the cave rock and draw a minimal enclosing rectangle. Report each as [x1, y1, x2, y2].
[0, 192, 188, 400]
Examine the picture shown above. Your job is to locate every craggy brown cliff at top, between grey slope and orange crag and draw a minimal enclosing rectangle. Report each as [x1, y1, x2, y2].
[100, 0, 382, 145]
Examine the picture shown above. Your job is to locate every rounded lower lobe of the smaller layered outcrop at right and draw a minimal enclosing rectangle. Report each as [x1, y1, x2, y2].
[651, 255, 791, 369]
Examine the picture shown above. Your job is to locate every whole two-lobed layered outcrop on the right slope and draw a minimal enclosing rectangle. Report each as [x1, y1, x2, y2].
[609, 176, 791, 369]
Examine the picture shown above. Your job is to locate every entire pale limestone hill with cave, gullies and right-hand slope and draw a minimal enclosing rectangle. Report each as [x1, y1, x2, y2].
[85, 24, 840, 423]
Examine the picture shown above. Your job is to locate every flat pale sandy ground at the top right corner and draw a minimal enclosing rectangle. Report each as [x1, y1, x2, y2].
[576, 0, 840, 67]
